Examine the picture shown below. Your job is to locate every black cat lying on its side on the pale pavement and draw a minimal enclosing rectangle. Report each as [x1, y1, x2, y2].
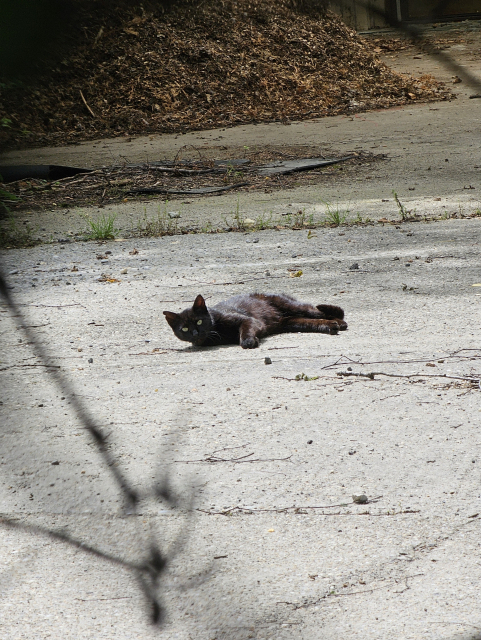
[164, 293, 347, 349]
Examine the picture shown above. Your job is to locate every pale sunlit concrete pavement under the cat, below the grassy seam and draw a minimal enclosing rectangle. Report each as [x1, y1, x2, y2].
[0, 219, 481, 640]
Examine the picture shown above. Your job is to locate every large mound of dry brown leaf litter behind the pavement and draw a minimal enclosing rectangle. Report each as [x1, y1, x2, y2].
[0, 0, 451, 146]
